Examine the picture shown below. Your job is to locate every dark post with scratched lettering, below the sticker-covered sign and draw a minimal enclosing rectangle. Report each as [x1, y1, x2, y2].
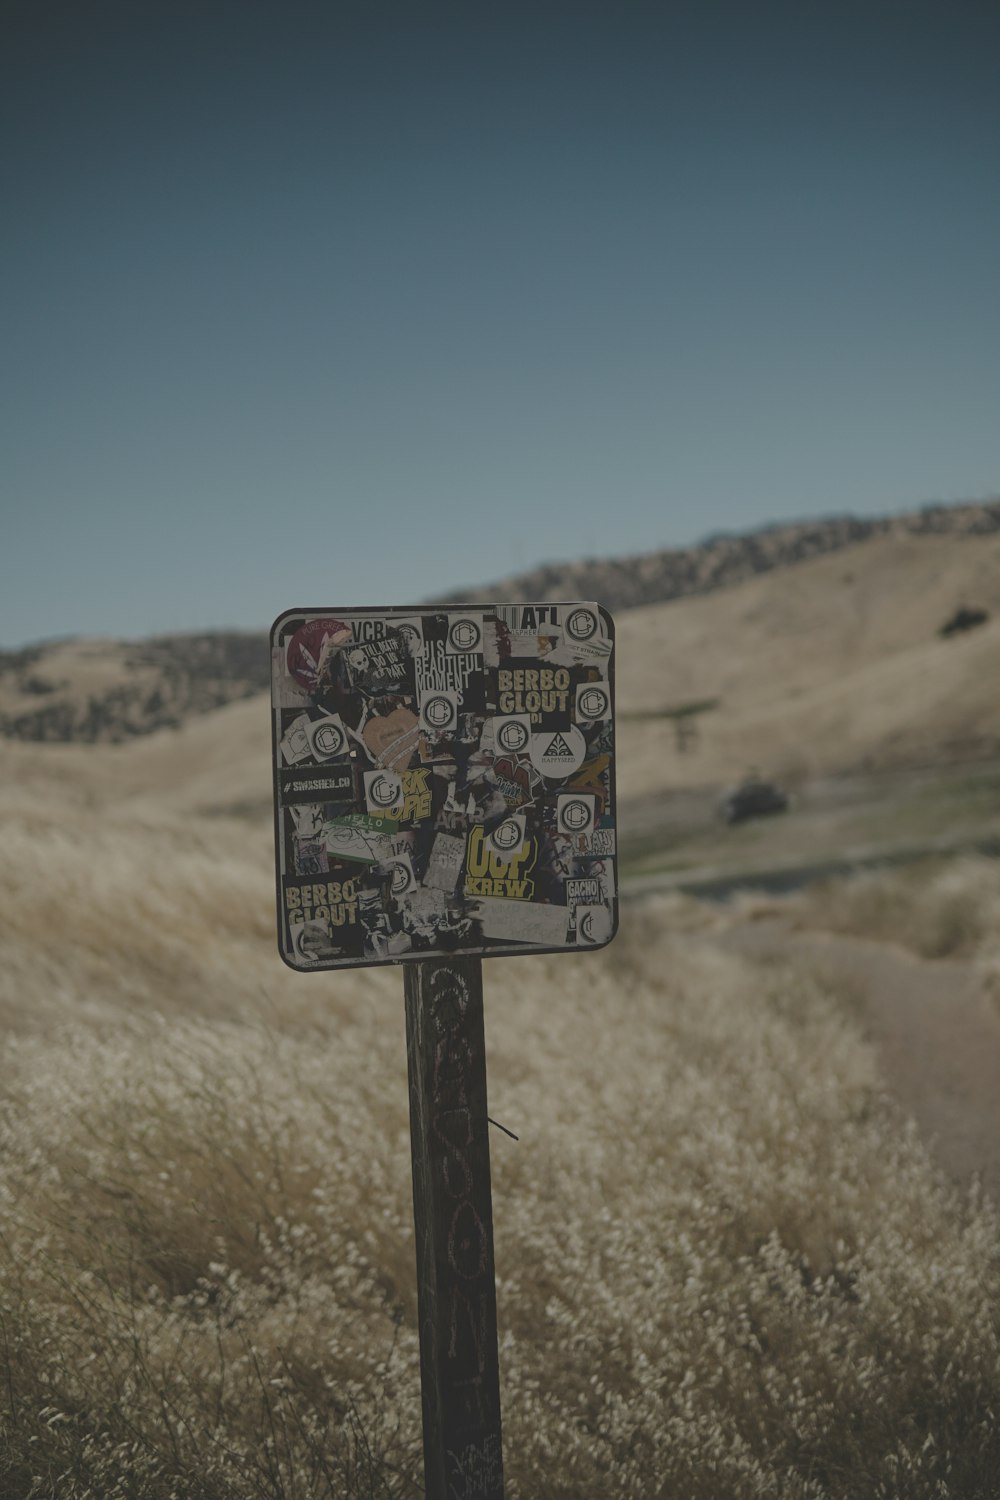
[405, 959, 504, 1500]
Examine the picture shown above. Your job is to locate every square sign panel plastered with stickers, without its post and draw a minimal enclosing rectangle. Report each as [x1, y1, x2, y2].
[271, 602, 618, 971]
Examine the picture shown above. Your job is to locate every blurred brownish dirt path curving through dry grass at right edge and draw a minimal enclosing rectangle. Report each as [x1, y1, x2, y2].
[711, 918, 1000, 1203]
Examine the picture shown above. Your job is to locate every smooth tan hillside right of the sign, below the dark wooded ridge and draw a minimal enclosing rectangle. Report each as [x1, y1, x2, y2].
[618, 536, 1000, 797]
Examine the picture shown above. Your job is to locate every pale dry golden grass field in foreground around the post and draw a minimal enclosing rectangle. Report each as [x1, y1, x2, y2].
[0, 785, 1000, 1500]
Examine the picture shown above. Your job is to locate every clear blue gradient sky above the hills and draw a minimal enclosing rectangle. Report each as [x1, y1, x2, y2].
[0, 0, 1000, 647]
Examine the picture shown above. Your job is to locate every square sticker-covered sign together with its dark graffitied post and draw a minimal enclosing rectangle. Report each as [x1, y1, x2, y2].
[271, 602, 618, 1500]
